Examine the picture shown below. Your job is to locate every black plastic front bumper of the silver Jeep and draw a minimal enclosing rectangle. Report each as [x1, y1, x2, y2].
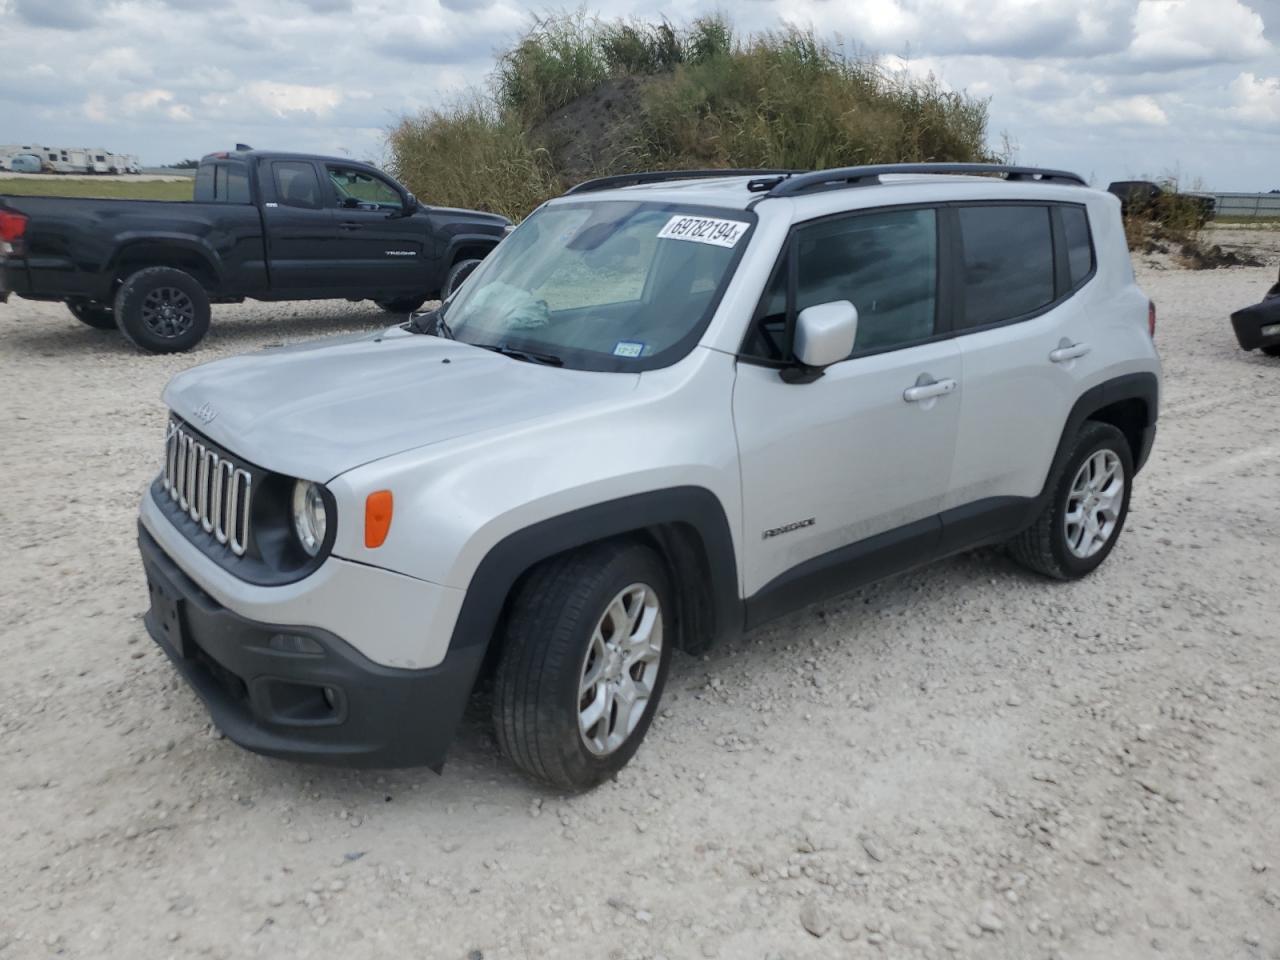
[138, 524, 484, 771]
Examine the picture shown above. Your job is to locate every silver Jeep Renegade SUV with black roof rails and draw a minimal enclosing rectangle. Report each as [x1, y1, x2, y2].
[140, 165, 1160, 788]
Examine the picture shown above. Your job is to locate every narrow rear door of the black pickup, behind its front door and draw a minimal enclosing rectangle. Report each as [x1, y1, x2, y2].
[259, 160, 343, 300]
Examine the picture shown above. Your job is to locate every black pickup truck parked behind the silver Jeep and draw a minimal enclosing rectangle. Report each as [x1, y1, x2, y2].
[0, 147, 511, 353]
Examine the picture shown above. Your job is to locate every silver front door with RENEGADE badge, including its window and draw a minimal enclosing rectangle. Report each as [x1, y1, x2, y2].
[733, 209, 961, 622]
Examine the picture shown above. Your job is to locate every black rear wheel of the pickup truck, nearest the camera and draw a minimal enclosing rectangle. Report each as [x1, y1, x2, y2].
[115, 266, 209, 353]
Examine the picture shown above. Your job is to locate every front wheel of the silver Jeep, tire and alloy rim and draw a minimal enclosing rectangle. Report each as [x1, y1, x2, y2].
[493, 544, 675, 791]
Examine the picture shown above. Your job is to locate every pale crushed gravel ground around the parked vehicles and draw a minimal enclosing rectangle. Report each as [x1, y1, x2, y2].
[0, 232, 1280, 960]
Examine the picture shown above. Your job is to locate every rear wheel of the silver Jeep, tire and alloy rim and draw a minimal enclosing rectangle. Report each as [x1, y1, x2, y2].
[1009, 420, 1133, 580]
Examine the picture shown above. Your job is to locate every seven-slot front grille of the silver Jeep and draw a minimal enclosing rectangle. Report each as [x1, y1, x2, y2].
[164, 420, 253, 557]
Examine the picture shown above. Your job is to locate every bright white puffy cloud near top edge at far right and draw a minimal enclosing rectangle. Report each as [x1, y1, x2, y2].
[1129, 0, 1271, 68]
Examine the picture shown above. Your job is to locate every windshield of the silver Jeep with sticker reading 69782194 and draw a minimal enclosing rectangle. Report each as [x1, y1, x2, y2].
[444, 201, 754, 371]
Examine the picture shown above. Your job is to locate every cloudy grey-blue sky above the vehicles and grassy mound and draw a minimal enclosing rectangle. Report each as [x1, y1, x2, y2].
[0, 0, 1280, 191]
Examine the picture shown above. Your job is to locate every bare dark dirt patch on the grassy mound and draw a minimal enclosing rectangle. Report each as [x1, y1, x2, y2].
[529, 77, 660, 184]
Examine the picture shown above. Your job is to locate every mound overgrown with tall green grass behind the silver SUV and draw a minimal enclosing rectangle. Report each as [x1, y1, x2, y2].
[388, 14, 992, 218]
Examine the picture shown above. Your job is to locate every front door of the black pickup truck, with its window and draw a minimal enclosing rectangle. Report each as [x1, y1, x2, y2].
[324, 163, 436, 297]
